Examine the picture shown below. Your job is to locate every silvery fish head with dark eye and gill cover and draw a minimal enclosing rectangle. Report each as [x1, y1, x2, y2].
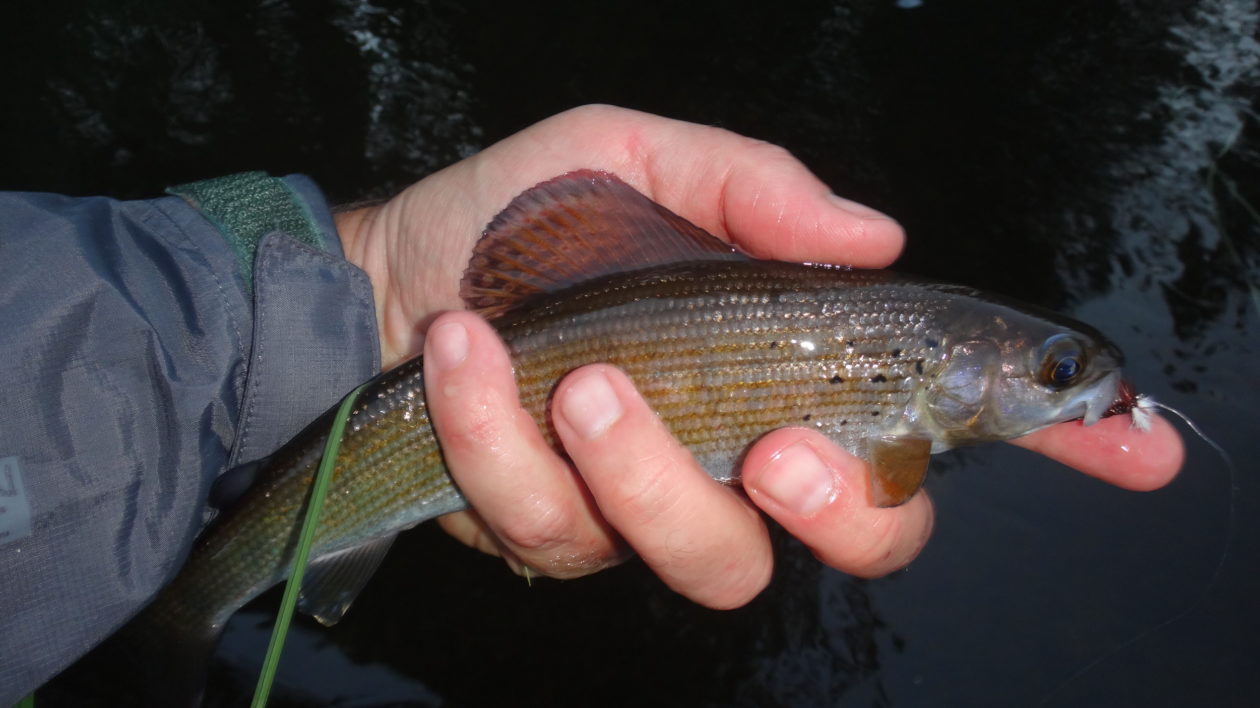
[919, 294, 1124, 447]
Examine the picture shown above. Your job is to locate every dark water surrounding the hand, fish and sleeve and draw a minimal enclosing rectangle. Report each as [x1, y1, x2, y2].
[0, 0, 1260, 707]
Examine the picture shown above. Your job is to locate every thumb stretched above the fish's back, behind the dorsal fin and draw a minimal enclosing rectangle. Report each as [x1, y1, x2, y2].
[474, 106, 905, 267]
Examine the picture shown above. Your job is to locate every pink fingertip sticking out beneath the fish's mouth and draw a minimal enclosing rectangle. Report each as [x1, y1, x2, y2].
[1011, 416, 1186, 491]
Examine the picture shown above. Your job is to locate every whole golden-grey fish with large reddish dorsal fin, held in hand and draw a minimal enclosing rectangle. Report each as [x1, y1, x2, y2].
[113, 170, 1135, 700]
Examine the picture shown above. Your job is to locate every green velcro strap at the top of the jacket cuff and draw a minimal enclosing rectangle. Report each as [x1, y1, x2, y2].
[166, 171, 328, 292]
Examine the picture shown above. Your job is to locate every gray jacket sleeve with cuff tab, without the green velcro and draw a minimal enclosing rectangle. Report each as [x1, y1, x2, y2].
[0, 176, 379, 705]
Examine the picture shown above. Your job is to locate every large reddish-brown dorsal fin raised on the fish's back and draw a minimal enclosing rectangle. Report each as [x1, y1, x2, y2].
[460, 170, 746, 319]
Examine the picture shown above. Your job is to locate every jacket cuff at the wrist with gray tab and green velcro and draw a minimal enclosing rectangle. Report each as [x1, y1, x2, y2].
[170, 173, 381, 469]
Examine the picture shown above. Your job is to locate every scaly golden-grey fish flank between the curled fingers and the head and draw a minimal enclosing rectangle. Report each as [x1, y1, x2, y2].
[500, 262, 944, 481]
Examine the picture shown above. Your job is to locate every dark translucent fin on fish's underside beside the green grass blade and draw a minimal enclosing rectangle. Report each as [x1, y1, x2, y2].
[297, 534, 398, 626]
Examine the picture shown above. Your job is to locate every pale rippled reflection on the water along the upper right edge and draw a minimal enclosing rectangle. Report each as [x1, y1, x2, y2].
[1063, 1, 1260, 340]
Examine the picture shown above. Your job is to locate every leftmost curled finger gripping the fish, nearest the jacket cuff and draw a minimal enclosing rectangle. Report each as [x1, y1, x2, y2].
[425, 312, 621, 577]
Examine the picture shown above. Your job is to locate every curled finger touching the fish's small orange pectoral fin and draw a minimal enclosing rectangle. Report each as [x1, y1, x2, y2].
[743, 428, 932, 577]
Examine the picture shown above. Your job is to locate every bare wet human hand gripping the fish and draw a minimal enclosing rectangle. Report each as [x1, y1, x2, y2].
[338, 107, 1182, 607]
